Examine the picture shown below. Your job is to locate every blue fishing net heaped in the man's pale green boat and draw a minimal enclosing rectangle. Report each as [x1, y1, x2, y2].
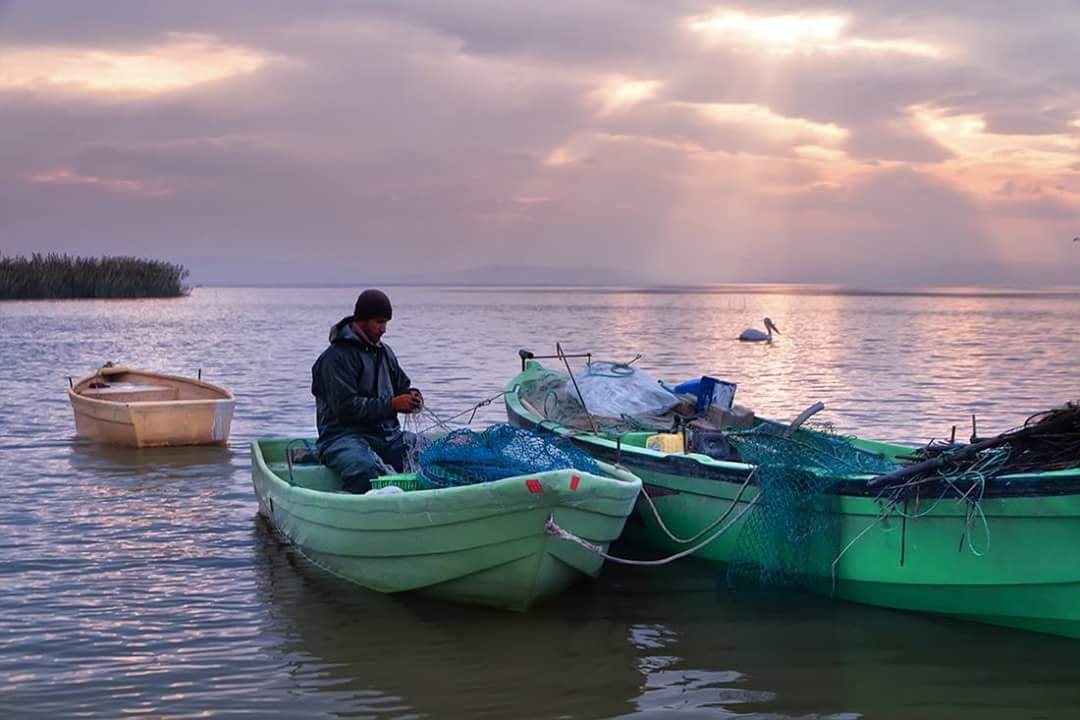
[417, 423, 600, 489]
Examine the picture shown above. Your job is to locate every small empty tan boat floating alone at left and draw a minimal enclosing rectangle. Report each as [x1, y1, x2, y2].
[68, 368, 235, 448]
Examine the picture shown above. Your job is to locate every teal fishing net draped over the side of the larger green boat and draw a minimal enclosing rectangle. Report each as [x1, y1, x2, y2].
[726, 422, 895, 594]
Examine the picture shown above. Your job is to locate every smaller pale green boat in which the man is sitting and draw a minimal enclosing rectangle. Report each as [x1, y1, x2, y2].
[252, 439, 642, 611]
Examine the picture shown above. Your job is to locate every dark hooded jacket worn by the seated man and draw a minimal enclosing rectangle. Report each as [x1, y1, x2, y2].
[311, 317, 409, 447]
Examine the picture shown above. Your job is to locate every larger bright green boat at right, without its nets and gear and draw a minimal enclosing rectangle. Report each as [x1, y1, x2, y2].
[505, 361, 1080, 638]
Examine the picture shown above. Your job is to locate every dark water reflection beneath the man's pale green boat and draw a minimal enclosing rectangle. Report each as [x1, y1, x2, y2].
[253, 518, 642, 718]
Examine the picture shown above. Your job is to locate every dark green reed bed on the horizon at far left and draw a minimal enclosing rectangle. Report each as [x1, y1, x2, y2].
[0, 253, 190, 300]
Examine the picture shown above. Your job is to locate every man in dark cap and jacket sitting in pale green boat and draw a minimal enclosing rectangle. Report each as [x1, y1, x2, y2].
[311, 289, 423, 493]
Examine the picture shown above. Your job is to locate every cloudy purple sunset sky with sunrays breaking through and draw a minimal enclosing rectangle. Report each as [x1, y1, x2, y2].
[0, 0, 1080, 287]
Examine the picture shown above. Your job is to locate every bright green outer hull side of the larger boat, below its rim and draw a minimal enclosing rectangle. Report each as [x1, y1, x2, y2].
[623, 474, 1080, 638]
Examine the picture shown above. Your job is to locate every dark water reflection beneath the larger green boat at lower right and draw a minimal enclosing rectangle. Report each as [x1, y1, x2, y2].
[602, 561, 1080, 720]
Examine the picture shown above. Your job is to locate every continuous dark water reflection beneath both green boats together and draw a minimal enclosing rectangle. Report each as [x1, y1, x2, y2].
[253, 509, 1080, 720]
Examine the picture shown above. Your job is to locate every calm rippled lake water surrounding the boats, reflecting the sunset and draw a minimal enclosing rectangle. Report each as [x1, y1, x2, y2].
[0, 288, 1080, 720]
